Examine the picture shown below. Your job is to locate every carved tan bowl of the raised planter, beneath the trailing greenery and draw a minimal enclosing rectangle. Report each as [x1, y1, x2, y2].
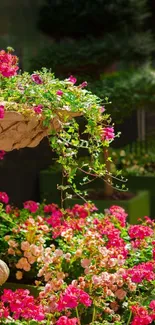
[0, 109, 81, 151]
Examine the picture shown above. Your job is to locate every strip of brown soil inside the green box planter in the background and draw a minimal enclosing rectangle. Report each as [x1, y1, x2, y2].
[87, 190, 136, 201]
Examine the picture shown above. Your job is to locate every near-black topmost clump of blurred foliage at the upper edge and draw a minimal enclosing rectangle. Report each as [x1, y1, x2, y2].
[38, 0, 149, 39]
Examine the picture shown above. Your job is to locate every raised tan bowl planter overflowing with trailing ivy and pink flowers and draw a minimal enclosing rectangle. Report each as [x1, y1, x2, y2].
[0, 49, 124, 205]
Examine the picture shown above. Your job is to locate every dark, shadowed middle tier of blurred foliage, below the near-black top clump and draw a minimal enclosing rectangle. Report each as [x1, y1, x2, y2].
[29, 31, 154, 81]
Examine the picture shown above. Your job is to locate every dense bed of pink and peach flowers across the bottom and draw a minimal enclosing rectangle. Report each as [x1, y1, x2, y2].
[0, 193, 155, 325]
